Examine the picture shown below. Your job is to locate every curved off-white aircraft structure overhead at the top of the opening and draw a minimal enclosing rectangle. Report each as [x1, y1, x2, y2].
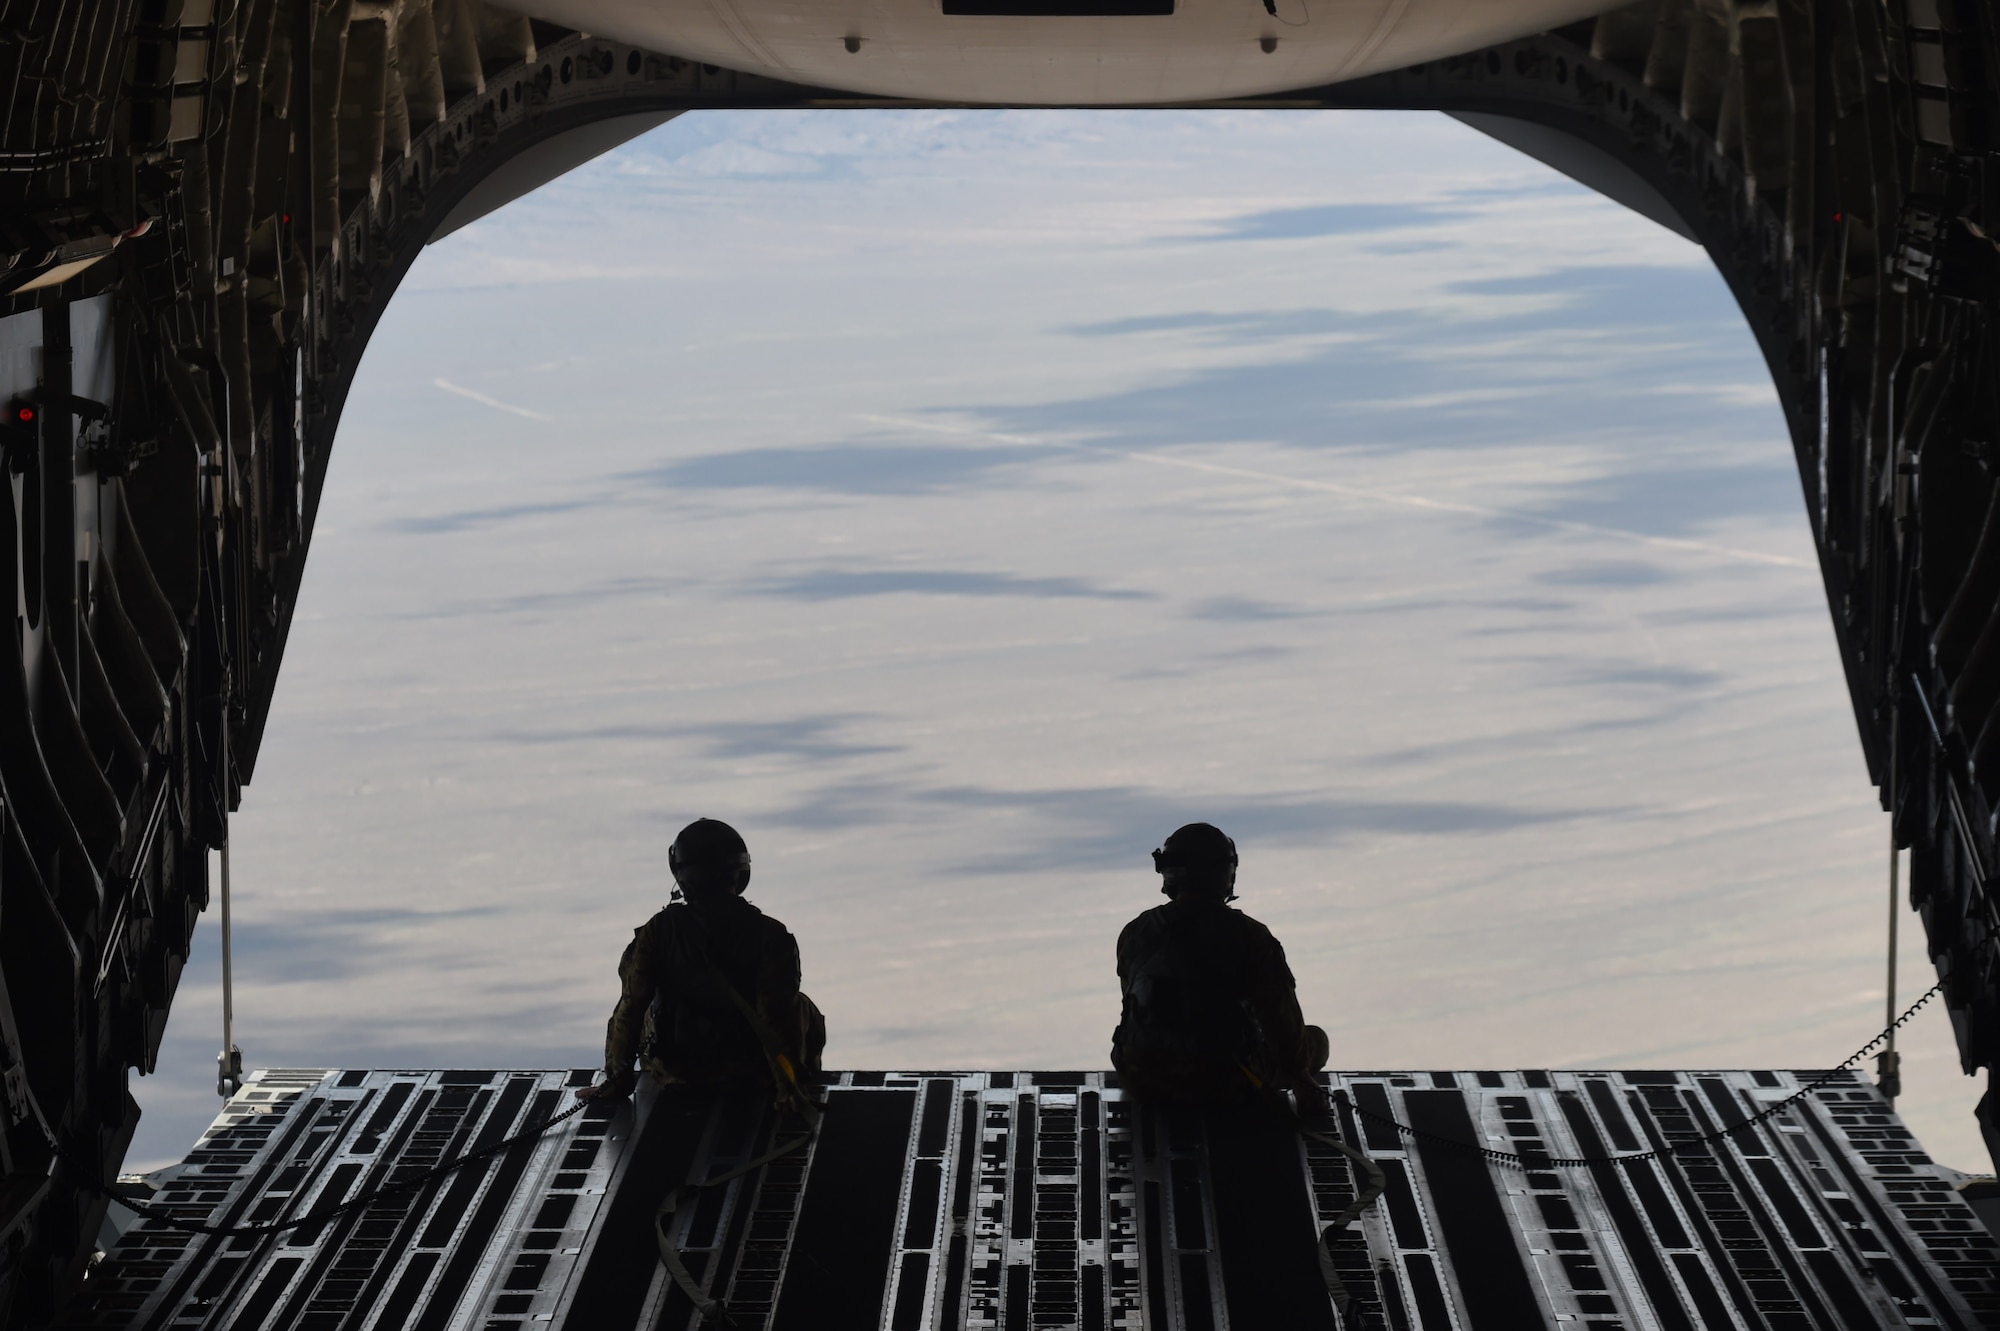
[526, 0, 1622, 106]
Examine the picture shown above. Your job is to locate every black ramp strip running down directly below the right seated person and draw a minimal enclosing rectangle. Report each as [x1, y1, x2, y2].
[1208, 1109, 1338, 1331]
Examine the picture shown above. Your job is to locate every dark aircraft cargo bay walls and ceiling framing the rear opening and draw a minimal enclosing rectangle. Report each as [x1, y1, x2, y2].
[0, 0, 2000, 1327]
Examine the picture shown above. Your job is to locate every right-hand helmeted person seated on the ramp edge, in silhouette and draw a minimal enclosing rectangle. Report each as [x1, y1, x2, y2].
[1112, 823, 1328, 1113]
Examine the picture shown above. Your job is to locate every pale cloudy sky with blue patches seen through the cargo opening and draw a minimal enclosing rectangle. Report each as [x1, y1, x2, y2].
[130, 112, 1986, 1169]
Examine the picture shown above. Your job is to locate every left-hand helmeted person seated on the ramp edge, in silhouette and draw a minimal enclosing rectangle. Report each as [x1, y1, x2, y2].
[576, 817, 826, 1103]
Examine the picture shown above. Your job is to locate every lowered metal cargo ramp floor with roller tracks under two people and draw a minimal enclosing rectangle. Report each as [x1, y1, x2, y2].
[54, 1069, 2000, 1331]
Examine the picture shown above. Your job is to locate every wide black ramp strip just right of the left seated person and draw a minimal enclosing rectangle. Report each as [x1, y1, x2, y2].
[772, 1091, 916, 1331]
